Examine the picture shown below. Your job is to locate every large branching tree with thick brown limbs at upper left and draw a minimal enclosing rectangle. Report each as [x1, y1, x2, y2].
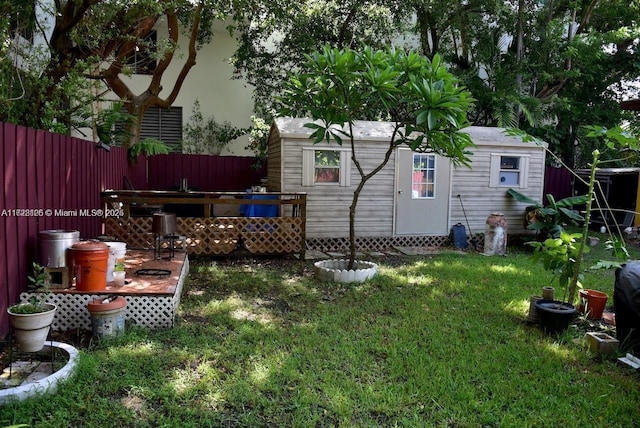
[0, 0, 231, 145]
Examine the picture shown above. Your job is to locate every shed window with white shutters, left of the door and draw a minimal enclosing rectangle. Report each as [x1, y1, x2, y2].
[302, 147, 351, 187]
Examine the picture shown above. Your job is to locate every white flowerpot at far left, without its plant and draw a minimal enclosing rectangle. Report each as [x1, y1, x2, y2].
[7, 303, 57, 352]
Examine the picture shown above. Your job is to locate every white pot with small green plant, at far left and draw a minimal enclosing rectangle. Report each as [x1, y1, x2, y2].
[7, 263, 57, 352]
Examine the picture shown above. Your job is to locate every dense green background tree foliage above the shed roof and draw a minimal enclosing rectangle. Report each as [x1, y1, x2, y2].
[234, 0, 640, 166]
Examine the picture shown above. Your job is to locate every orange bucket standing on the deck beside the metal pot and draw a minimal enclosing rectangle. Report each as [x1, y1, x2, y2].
[70, 241, 109, 291]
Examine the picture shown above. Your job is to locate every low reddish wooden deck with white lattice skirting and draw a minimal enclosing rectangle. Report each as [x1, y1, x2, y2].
[20, 250, 189, 331]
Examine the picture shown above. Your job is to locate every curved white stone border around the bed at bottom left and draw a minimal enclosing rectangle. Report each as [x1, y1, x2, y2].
[0, 341, 80, 405]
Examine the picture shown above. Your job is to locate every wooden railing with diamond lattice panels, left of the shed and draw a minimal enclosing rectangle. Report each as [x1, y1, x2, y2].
[101, 190, 307, 255]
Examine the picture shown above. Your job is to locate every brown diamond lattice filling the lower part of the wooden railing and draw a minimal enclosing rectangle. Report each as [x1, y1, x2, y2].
[105, 217, 304, 255]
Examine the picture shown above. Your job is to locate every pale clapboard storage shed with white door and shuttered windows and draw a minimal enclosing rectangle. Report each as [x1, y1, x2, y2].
[267, 118, 545, 249]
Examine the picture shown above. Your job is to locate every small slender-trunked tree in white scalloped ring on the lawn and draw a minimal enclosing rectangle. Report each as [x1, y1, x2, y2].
[278, 46, 473, 282]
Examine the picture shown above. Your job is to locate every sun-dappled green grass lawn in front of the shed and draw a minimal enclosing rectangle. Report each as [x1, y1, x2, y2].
[0, 239, 640, 427]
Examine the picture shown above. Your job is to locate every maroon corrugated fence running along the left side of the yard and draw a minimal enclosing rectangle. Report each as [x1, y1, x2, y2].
[0, 123, 130, 336]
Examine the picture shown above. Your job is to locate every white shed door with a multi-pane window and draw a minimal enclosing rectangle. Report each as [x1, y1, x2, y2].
[395, 148, 451, 235]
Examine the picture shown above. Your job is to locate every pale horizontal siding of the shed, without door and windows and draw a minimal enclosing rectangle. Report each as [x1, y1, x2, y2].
[268, 118, 545, 238]
